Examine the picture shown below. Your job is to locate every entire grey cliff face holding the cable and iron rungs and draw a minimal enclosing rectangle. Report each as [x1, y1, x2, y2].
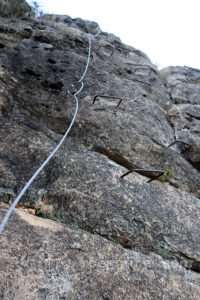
[0, 15, 200, 300]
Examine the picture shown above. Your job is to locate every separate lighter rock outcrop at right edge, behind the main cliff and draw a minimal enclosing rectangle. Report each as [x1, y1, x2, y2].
[161, 67, 200, 170]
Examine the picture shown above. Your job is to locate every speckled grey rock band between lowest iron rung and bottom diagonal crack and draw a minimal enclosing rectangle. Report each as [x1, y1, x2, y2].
[17, 151, 200, 269]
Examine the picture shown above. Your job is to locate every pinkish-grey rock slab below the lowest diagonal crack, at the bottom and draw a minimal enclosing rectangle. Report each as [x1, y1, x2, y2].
[0, 205, 200, 300]
